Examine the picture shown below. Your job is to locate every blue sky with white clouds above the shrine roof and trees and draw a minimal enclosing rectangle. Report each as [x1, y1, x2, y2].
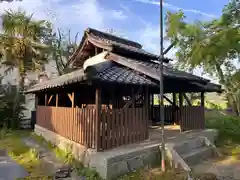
[0, 0, 228, 53]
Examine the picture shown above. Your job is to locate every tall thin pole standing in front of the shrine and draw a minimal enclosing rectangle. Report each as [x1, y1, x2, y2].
[159, 0, 165, 172]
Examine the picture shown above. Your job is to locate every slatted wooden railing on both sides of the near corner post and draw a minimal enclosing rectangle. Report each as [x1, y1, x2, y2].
[37, 106, 148, 151]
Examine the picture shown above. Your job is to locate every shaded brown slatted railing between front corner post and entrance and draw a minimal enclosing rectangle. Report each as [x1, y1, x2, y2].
[100, 108, 148, 150]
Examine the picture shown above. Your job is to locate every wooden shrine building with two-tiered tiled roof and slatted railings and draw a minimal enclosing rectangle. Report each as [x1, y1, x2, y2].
[26, 28, 221, 151]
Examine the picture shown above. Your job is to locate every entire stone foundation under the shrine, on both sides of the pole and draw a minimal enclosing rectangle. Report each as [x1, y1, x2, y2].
[35, 125, 217, 179]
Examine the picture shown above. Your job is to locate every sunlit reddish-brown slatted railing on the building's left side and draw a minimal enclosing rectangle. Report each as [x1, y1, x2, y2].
[37, 106, 96, 148]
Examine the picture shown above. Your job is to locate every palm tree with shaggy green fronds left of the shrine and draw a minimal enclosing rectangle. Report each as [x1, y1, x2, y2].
[0, 10, 51, 90]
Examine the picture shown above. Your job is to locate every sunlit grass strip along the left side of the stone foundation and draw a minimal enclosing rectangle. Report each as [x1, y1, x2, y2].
[32, 134, 102, 180]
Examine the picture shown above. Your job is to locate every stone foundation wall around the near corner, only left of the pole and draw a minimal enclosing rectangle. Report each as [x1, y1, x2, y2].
[35, 125, 159, 179]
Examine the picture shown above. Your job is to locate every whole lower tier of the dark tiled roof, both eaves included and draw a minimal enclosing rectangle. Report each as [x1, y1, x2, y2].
[26, 53, 221, 93]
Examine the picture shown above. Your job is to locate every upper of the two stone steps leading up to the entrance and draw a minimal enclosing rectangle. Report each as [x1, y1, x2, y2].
[174, 138, 205, 155]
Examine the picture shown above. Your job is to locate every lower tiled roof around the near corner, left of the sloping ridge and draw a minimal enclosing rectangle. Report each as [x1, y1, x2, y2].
[26, 61, 157, 93]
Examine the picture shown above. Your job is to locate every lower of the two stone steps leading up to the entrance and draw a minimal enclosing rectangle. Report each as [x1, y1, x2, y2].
[181, 146, 214, 167]
